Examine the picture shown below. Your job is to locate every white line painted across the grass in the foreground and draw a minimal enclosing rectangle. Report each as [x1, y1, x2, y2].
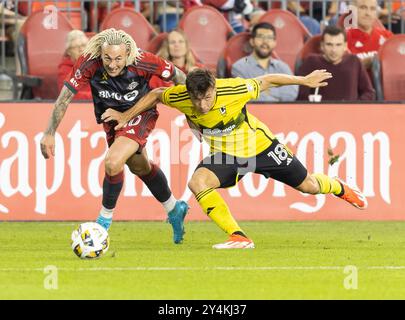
[0, 266, 405, 272]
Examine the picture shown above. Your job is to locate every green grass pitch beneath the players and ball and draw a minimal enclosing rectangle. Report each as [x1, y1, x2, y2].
[0, 221, 405, 300]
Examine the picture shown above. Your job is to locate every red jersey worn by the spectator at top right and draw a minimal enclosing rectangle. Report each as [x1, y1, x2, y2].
[347, 28, 392, 58]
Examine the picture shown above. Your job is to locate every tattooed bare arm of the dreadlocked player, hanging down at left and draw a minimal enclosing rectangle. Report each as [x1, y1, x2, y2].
[40, 86, 74, 159]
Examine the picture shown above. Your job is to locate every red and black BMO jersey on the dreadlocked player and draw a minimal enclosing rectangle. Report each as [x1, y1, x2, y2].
[64, 52, 175, 123]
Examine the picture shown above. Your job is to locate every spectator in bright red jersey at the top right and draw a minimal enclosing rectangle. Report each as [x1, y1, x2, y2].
[347, 0, 392, 69]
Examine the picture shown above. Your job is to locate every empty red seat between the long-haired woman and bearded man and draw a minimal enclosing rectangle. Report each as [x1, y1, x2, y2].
[179, 6, 234, 70]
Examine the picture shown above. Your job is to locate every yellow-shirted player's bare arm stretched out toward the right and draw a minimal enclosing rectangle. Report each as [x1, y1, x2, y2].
[256, 70, 332, 91]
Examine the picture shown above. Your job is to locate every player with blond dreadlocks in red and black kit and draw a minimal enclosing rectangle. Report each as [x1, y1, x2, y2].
[41, 29, 188, 243]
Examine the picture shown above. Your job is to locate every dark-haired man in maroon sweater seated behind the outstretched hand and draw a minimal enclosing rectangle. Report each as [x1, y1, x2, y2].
[298, 26, 375, 101]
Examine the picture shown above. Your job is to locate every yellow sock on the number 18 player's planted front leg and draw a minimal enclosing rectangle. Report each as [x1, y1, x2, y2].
[196, 189, 242, 235]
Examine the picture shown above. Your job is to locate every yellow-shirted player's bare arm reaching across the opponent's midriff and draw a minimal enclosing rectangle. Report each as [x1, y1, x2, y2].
[101, 88, 166, 130]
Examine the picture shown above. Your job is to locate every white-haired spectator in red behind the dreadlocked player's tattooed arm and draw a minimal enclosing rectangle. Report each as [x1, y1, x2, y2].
[58, 30, 92, 100]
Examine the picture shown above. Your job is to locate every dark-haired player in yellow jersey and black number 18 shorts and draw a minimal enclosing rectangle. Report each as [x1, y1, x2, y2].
[102, 69, 367, 249]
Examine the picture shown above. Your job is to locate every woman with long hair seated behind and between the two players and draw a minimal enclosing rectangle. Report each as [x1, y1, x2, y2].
[149, 30, 204, 88]
